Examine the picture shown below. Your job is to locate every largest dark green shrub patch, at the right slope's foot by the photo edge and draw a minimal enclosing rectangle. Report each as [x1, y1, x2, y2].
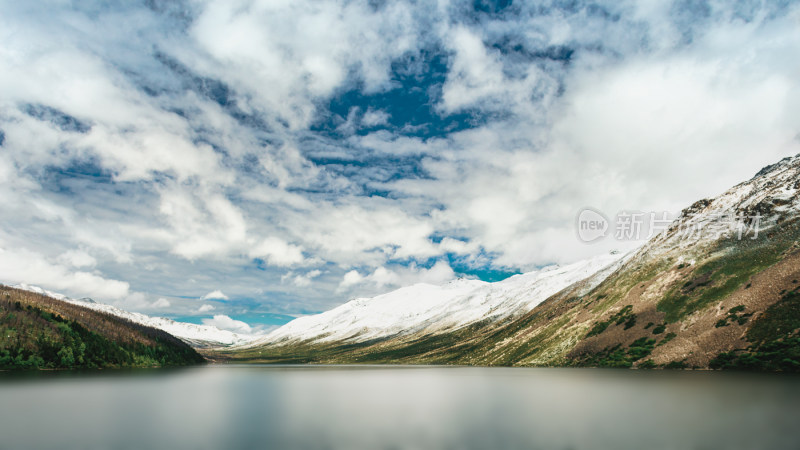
[709, 290, 800, 372]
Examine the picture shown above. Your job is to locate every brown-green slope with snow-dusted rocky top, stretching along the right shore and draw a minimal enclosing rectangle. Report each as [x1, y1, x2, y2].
[221, 155, 800, 371]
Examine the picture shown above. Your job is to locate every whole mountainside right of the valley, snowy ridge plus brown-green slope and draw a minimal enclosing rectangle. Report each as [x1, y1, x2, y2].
[222, 156, 800, 371]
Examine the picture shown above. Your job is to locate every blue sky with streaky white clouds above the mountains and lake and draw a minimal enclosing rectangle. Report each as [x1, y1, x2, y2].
[0, 0, 800, 332]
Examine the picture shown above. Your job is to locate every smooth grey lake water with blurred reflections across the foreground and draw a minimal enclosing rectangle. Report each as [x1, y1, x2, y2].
[0, 366, 800, 450]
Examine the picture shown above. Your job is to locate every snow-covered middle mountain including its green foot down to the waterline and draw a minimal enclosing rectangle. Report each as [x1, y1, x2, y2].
[223, 254, 624, 362]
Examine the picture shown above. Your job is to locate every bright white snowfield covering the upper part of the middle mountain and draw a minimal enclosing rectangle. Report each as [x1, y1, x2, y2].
[248, 254, 622, 347]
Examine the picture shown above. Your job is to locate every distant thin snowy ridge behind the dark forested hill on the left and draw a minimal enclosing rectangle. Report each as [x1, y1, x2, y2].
[13, 284, 258, 348]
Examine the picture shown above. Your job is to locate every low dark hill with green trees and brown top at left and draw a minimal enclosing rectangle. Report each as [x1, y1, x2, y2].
[0, 286, 204, 369]
